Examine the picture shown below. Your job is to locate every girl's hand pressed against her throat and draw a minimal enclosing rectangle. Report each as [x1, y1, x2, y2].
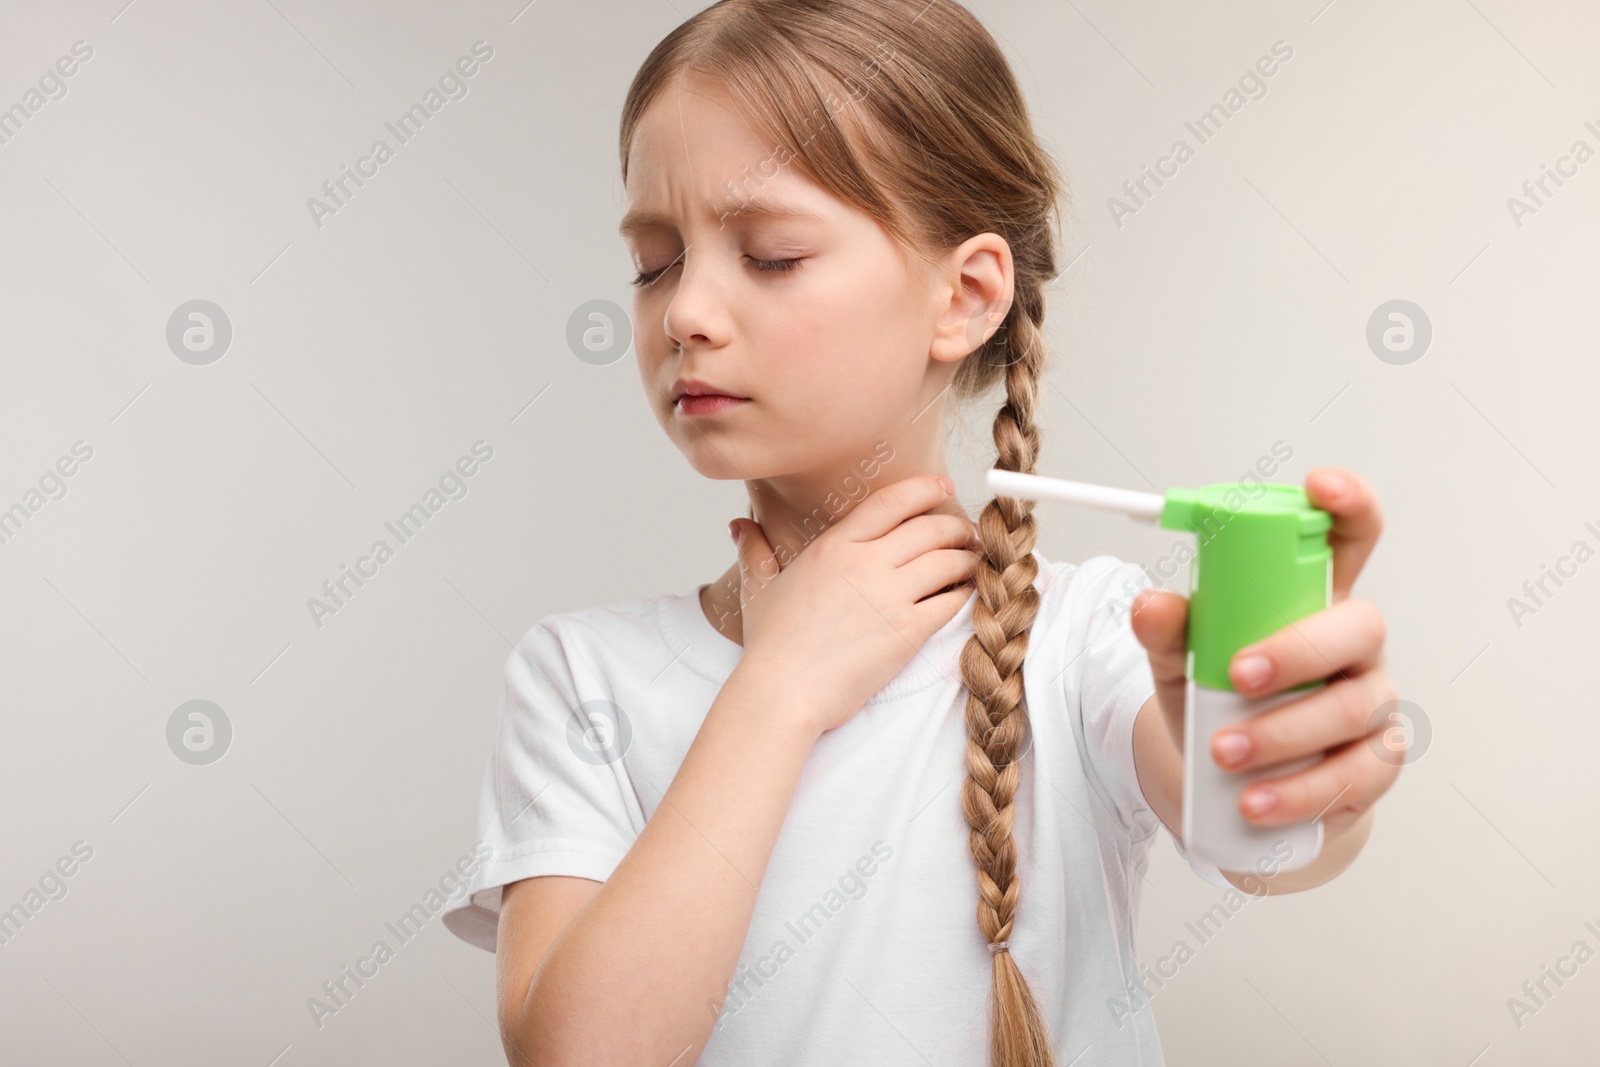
[734, 475, 979, 736]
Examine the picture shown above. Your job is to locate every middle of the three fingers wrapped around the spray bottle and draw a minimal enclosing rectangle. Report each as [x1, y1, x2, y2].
[1210, 670, 1394, 771]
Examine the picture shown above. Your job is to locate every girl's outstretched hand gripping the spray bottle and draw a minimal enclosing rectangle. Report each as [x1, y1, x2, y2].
[1131, 467, 1400, 837]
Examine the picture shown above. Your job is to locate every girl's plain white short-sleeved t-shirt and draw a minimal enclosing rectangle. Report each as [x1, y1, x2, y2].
[443, 550, 1230, 1067]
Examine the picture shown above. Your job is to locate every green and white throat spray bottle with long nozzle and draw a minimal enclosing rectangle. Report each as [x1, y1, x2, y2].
[989, 470, 1333, 875]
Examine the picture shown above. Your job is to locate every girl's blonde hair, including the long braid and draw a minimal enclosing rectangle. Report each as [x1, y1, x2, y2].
[619, 0, 1067, 1067]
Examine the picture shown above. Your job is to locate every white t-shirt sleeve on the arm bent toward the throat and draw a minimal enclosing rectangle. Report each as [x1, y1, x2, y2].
[443, 619, 643, 952]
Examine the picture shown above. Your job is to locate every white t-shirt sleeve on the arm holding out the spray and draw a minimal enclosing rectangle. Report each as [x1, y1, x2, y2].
[1067, 555, 1232, 888]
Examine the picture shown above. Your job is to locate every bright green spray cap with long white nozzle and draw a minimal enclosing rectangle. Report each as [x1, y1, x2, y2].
[989, 470, 1333, 689]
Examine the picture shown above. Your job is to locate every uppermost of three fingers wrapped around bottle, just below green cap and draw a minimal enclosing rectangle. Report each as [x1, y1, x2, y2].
[1227, 597, 1384, 696]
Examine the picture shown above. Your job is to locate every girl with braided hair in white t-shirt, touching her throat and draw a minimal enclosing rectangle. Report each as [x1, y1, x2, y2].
[445, 0, 1397, 1067]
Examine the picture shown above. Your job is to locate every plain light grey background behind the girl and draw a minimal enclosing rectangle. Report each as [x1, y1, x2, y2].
[0, 0, 1600, 1067]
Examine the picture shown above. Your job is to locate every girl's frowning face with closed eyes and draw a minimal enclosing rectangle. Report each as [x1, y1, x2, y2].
[622, 75, 957, 480]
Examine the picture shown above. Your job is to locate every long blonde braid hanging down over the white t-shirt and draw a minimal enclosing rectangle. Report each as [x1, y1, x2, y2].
[960, 295, 1056, 1067]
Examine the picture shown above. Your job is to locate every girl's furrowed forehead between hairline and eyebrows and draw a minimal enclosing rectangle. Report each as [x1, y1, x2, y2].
[619, 75, 832, 235]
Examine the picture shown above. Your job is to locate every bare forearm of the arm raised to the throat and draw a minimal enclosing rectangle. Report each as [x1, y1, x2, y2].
[514, 664, 818, 1067]
